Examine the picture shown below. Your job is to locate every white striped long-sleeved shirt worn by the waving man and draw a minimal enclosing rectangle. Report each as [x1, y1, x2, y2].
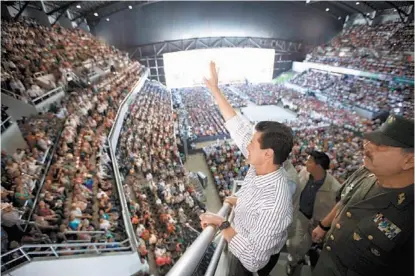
[225, 116, 293, 272]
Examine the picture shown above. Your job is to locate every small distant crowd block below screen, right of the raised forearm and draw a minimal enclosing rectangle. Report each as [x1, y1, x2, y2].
[232, 83, 279, 105]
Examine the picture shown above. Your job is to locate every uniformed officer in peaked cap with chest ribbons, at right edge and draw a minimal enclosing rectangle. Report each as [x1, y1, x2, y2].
[313, 115, 414, 276]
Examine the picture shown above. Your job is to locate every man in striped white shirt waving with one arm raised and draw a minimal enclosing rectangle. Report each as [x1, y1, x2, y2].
[201, 62, 293, 276]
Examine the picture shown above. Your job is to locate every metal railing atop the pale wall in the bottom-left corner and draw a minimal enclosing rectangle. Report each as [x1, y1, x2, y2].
[1, 239, 131, 271]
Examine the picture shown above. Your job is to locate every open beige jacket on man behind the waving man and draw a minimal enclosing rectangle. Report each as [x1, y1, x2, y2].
[293, 167, 341, 221]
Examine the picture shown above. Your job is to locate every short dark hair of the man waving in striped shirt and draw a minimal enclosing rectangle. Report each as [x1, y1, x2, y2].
[255, 121, 294, 165]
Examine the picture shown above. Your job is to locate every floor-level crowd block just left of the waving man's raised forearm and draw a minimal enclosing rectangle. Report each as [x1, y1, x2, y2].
[173, 87, 228, 139]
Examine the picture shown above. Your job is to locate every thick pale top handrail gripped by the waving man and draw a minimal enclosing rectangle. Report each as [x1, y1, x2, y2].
[167, 203, 231, 276]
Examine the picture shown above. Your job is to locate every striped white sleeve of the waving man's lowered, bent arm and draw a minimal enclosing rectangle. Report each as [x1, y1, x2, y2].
[229, 201, 292, 272]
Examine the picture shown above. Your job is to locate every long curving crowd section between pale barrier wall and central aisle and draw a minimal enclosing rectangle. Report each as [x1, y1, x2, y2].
[117, 82, 204, 275]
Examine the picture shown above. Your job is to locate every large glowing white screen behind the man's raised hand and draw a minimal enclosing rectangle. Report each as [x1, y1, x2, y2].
[163, 48, 275, 88]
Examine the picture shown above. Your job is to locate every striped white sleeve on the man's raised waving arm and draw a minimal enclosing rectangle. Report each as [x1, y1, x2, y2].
[225, 115, 252, 158]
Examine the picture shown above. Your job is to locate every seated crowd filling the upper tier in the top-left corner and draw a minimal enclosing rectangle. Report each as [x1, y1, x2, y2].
[1, 17, 127, 101]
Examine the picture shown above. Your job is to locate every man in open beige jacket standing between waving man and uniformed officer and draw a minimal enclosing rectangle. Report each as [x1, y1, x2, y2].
[286, 151, 340, 275]
